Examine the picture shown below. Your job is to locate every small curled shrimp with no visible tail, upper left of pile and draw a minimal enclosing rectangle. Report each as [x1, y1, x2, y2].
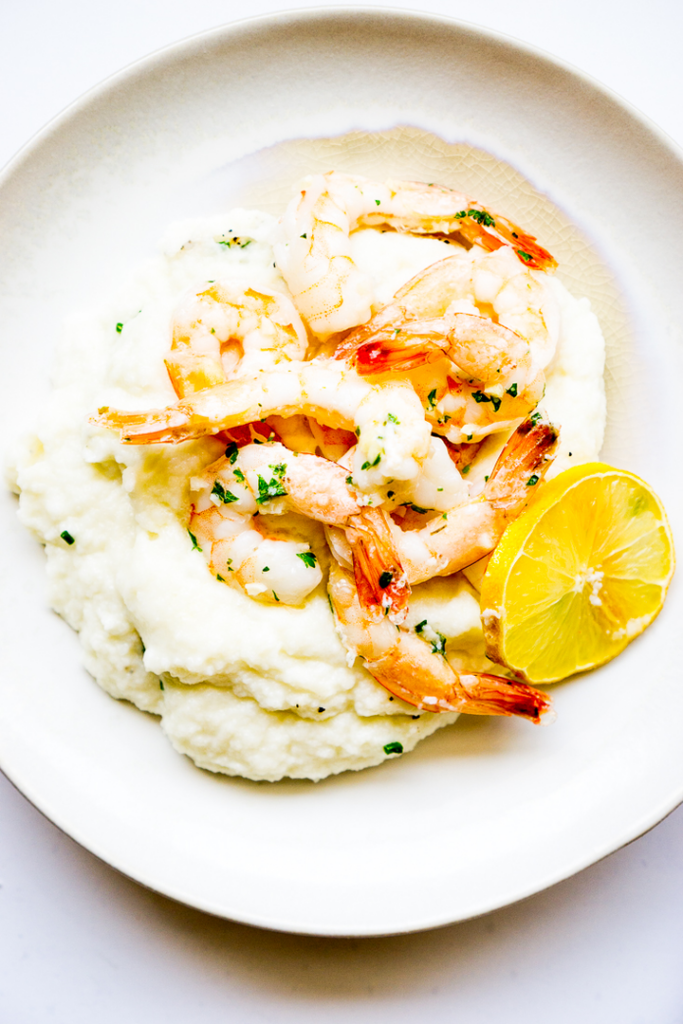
[165, 281, 308, 398]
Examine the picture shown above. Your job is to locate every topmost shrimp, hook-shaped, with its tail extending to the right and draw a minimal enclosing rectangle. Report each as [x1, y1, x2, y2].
[274, 171, 557, 338]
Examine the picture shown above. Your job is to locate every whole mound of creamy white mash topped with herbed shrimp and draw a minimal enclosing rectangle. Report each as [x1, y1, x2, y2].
[7, 171, 605, 781]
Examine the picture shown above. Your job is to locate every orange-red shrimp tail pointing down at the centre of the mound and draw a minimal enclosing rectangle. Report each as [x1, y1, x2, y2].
[346, 510, 411, 623]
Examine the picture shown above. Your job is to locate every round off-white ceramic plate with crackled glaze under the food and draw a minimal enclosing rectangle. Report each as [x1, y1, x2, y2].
[0, 8, 683, 935]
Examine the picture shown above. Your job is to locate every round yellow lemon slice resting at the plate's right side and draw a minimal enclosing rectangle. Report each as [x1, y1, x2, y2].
[481, 462, 675, 683]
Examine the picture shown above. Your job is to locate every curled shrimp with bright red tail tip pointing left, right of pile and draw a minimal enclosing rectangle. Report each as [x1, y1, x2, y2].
[335, 249, 559, 443]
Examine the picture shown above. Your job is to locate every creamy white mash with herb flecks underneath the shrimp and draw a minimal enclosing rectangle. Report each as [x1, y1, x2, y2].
[7, 197, 604, 780]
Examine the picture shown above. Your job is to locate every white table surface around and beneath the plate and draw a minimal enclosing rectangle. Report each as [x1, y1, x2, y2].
[0, 0, 683, 1024]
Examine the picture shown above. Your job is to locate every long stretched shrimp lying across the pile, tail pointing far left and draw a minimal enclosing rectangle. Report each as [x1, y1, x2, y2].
[92, 360, 444, 504]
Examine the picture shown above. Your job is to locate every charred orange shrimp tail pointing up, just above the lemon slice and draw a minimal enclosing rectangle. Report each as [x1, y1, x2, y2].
[483, 413, 559, 512]
